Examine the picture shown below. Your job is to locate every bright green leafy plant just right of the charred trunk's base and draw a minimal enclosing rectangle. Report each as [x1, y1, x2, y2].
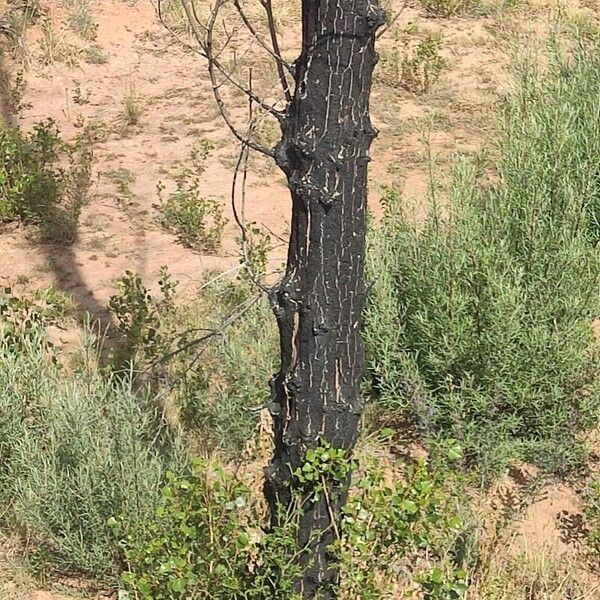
[336, 441, 467, 600]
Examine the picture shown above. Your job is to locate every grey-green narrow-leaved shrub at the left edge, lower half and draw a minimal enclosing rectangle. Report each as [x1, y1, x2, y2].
[0, 325, 184, 579]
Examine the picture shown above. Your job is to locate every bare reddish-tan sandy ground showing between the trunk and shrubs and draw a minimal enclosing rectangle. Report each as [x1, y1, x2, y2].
[0, 0, 600, 600]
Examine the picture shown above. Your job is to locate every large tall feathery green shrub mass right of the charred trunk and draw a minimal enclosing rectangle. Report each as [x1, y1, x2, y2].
[365, 35, 600, 471]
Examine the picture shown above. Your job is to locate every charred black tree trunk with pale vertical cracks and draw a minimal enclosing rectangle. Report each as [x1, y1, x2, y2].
[265, 0, 384, 598]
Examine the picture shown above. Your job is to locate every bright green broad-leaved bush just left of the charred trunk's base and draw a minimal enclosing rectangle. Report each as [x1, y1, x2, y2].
[118, 459, 297, 600]
